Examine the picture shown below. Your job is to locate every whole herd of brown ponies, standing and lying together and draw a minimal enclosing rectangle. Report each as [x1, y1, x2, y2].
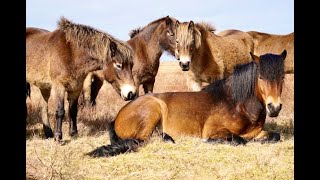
[26, 16, 294, 157]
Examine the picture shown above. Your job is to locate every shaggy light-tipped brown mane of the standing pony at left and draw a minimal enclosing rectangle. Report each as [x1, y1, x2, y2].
[58, 17, 132, 63]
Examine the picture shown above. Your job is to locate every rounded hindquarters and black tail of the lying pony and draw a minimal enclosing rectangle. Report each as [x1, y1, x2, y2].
[87, 95, 167, 157]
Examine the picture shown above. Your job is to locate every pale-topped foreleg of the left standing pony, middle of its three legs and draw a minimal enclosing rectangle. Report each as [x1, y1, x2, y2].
[52, 83, 65, 142]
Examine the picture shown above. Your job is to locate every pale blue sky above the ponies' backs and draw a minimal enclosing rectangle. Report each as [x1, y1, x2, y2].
[26, 0, 294, 60]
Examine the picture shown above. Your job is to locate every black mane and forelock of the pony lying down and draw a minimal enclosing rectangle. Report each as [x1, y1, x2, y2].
[202, 54, 284, 102]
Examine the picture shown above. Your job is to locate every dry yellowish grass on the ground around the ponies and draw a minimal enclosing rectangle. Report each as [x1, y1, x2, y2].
[26, 61, 294, 179]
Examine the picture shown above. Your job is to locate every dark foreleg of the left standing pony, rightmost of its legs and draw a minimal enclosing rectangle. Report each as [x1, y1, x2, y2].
[68, 92, 80, 136]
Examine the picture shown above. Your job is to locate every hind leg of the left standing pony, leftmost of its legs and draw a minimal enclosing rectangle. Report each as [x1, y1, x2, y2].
[40, 89, 53, 138]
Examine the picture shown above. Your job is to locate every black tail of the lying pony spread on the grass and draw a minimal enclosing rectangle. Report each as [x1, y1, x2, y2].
[86, 139, 143, 157]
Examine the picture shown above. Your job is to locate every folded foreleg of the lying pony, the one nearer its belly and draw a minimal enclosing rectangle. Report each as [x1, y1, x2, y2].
[205, 129, 247, 146]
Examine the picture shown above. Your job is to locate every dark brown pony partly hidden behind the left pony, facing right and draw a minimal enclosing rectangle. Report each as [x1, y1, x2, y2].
[83, 16, 176, 105]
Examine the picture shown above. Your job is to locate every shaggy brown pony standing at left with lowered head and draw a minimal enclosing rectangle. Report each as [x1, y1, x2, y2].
[26, 17, 136, 141]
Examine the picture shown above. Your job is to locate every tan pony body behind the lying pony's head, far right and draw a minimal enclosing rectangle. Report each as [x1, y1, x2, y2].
[247, 31, 294, 74]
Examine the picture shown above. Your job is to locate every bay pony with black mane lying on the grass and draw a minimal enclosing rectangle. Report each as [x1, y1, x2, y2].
[88, 51, 287, 157]
